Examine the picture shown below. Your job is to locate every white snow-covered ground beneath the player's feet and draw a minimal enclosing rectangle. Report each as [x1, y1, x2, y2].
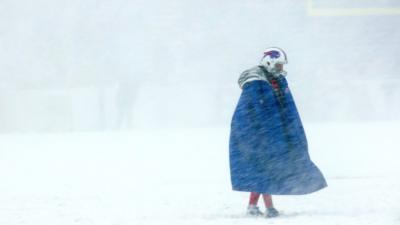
[0, 122, 400, 225]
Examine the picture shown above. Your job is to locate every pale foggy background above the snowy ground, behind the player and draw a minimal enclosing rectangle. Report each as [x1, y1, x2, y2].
[0, 0, 400, 133]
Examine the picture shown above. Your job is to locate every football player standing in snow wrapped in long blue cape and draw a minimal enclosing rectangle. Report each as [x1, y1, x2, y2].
[229, 47, 327, 217]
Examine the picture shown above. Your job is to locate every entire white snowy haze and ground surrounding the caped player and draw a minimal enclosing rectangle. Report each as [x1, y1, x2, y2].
[0, 0, 400, 225]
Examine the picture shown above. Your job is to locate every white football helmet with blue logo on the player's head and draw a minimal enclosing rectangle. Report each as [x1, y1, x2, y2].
[260, 47, 288, 76]
